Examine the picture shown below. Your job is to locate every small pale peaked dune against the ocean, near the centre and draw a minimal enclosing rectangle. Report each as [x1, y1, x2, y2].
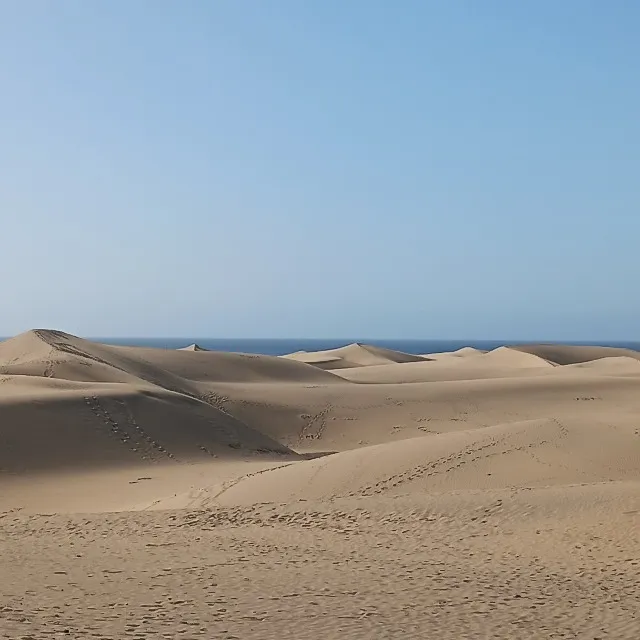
[282, 342, 425, 370]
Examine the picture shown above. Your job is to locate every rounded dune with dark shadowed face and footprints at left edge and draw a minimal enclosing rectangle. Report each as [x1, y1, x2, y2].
[0, 385, 298, 473]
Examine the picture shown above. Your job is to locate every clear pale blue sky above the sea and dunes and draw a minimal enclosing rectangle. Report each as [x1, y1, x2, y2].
[0, 0, 640, 340]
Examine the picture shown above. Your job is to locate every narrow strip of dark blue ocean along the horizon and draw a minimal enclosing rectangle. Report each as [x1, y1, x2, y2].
[90, 338, 640, 356]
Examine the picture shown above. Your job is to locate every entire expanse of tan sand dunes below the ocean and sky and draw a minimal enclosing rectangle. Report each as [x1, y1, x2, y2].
[0, 330, 640, 640]
